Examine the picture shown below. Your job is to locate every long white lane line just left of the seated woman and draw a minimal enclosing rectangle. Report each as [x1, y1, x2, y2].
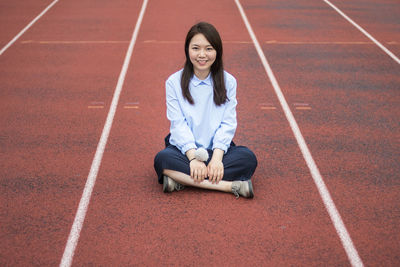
[60, 0, 148, 267]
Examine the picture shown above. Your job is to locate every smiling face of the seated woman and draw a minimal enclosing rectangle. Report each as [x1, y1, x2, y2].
[189, 33, 217, 78]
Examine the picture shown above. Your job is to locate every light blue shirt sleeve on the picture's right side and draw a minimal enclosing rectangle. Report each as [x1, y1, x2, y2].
[212, 76, 237, 153]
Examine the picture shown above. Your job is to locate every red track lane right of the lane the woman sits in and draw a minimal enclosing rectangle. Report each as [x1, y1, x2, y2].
[243, 1, 400, 266]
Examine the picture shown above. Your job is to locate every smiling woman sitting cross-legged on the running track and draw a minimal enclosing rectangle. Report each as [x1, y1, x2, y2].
[154, 22, 257, 198]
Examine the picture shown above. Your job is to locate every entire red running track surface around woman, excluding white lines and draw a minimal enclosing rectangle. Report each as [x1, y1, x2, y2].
[0, 0, 400, 266]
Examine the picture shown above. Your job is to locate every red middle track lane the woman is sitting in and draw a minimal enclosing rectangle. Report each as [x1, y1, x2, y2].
[74, 1, 354, 265]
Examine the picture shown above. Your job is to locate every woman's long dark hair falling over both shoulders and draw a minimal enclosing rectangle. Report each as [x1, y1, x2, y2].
[181, 22, 228, 106]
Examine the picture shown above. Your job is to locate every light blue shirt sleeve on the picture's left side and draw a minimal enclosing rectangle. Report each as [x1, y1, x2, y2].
[165, 79, 197, 154]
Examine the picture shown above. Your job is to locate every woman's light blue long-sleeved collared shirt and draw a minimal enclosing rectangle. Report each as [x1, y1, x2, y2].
[165, 70, 237, 154]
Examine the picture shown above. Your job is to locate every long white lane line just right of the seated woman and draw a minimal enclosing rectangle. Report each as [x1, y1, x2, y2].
[235, 0, 363, 266]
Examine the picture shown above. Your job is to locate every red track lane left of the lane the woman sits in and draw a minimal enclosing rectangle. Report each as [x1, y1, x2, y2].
[0, 1, 139, 266]
